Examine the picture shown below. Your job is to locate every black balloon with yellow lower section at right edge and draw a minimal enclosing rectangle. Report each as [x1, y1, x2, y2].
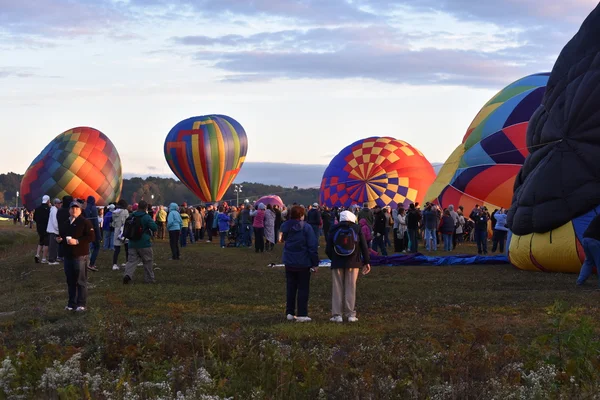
[507, 6, 600, 273]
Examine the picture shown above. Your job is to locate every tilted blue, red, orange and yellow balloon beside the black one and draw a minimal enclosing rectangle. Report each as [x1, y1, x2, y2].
[425, 73, 550, 213]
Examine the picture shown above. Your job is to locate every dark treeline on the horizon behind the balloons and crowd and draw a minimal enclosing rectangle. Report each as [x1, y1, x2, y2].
[0, 172, 319, 206]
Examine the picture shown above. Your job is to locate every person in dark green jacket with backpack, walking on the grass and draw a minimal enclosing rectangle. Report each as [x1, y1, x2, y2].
[123, 200, 158, 284]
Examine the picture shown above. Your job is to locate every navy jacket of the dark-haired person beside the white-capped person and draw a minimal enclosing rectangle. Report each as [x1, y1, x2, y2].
[281, 219, 319, 268]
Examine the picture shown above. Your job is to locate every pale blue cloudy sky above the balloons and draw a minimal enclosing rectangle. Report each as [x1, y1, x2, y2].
[0, 0, 597, 181]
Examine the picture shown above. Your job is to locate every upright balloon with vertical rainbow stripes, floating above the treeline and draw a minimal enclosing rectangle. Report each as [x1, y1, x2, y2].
[164, 115, 248, 202]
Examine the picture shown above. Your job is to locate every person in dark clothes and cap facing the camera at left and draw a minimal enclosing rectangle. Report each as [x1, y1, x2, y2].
[56, 201, 96, 311]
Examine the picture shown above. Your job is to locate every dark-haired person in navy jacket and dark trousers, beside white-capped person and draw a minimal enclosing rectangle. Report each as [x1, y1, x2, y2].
[281, 206, 319, 322]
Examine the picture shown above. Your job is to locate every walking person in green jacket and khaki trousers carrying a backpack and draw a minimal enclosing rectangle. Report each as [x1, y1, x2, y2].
[123, 200, 158, 284]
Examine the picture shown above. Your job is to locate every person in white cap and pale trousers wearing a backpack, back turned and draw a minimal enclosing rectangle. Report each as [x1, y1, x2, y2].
[325, 211, 371, 322]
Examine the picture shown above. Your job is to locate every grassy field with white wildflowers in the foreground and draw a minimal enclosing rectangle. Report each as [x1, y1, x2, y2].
[0, 223, 600, 399]
